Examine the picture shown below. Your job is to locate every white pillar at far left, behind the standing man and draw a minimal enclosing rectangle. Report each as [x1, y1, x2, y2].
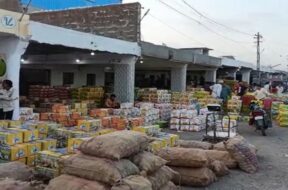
[0, 37, 28, 120]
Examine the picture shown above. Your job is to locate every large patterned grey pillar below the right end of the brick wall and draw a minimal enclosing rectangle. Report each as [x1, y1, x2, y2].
[114, 56, 137, 102]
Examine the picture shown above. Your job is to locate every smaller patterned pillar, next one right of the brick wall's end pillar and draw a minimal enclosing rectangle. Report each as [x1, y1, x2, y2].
[171, 64, 187, 92]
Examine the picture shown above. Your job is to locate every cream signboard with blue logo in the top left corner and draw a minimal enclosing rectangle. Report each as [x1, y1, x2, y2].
[0, 9, 29, 37]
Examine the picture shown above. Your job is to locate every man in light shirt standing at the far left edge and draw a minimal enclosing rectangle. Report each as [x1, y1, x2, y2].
[0, 80, 17, 120]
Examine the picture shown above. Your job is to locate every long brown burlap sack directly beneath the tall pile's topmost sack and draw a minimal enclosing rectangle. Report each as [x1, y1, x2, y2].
[62, 154, 139, 185]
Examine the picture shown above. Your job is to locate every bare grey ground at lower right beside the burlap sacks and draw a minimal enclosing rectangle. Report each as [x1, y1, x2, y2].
[165, 123, 288, 190]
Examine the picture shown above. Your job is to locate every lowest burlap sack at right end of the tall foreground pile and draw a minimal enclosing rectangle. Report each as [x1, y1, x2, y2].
[148, 166, 176, 190]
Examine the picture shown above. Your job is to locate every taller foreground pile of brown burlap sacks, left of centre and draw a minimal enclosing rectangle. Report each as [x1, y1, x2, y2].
[46, 131, 177, 190]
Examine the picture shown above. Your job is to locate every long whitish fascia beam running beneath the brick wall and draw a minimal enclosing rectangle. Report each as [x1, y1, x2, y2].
[30, 21, 141, 56]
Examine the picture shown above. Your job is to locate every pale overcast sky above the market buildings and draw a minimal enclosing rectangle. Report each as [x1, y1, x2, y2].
[123, 0, 288, 71]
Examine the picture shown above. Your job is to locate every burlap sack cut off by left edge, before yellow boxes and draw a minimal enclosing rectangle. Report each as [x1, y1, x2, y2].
[0, 162, 33, 181]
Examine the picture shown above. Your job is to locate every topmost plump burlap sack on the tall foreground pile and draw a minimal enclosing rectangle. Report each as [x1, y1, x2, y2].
[79, 131, 150, 160]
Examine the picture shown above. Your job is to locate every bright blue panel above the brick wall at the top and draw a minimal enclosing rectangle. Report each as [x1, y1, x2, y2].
[21, 0, 122, 10]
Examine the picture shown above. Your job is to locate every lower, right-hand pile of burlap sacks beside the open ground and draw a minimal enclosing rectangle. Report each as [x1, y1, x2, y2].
[157, 137, 258, 187]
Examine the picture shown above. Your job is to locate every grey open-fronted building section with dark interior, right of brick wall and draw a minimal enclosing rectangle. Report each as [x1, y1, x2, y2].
[136, 42, 221, 92]
